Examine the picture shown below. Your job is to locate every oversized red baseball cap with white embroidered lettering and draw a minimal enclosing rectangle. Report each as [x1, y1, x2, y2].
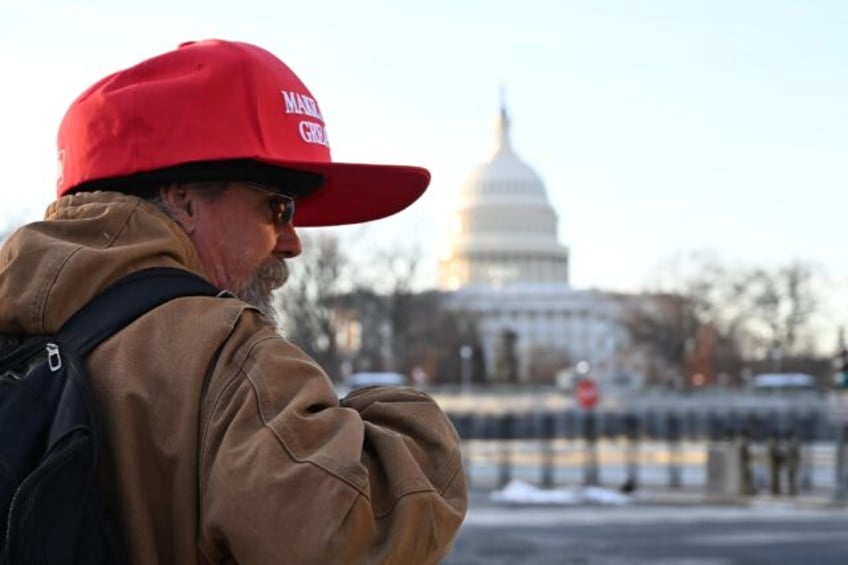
[57, 39, 430, 226]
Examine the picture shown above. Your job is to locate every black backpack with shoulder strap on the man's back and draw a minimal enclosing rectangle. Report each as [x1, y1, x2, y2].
[0, 268, 219, 565]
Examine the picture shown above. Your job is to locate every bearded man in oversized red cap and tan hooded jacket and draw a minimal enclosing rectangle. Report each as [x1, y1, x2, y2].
[0, 40, 466, 564]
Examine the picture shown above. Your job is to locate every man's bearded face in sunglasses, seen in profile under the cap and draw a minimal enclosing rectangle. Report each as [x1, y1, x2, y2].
[168, 183, 301, 320]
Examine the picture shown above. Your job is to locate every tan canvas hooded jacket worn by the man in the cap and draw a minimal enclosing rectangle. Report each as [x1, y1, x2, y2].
[0, 192, 466, 565]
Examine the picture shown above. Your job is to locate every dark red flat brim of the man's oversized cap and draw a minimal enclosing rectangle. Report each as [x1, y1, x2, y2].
[285, 163, 430, 227]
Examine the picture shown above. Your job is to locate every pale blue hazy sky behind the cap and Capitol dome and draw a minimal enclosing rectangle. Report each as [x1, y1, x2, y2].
[0, 0, 848, 334]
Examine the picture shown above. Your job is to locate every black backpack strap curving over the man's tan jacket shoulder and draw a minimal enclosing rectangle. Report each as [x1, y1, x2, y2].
[55, 267, 228, 357]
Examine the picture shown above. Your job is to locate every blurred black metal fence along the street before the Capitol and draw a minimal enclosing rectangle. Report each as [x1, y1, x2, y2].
[449, 409, 835, 490]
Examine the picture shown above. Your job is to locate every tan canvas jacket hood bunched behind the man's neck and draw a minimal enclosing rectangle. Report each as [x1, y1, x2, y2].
[0, 192, 206, 334]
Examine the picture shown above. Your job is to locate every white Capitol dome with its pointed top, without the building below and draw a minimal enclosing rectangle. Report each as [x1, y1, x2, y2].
[439, 103, 568, 289]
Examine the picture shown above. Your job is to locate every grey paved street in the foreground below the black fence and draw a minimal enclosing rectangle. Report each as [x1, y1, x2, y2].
[444, 484, 848, 565]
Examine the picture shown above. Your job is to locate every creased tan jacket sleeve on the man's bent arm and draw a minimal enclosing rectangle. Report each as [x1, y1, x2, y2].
[199, 326, 467, 565]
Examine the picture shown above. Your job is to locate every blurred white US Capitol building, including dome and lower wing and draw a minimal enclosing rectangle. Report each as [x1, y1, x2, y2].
[439, 106, 646, 388]
